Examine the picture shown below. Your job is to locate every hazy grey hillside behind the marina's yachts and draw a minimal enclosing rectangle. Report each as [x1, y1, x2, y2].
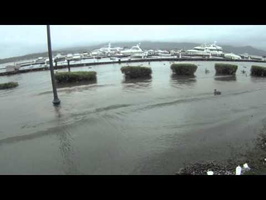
[0, 41, 266, 64]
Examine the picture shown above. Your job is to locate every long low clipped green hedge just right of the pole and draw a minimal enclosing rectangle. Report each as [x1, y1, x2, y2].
[55, 71, 96, 83]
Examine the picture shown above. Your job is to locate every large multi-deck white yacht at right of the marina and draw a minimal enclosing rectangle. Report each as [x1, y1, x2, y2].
[186, 42, 224, 56]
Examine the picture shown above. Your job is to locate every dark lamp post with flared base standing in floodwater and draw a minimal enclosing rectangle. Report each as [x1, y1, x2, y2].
[47, 25, 60, 106]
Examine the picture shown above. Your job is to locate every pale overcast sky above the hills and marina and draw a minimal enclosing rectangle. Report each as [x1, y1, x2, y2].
[0, 25, 266, 58]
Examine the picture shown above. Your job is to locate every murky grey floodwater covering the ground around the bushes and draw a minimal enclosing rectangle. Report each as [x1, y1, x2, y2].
[0, 62, 266, 175]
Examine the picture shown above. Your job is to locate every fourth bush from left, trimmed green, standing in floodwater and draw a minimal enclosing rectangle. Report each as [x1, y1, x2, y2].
[171, 63, 198, 76]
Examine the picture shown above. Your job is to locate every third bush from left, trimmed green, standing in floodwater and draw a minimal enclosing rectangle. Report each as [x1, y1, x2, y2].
[121, 66, 152, 78]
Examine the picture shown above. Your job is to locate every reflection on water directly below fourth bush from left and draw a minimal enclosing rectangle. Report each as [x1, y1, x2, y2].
[171, 74, 197, 87]
